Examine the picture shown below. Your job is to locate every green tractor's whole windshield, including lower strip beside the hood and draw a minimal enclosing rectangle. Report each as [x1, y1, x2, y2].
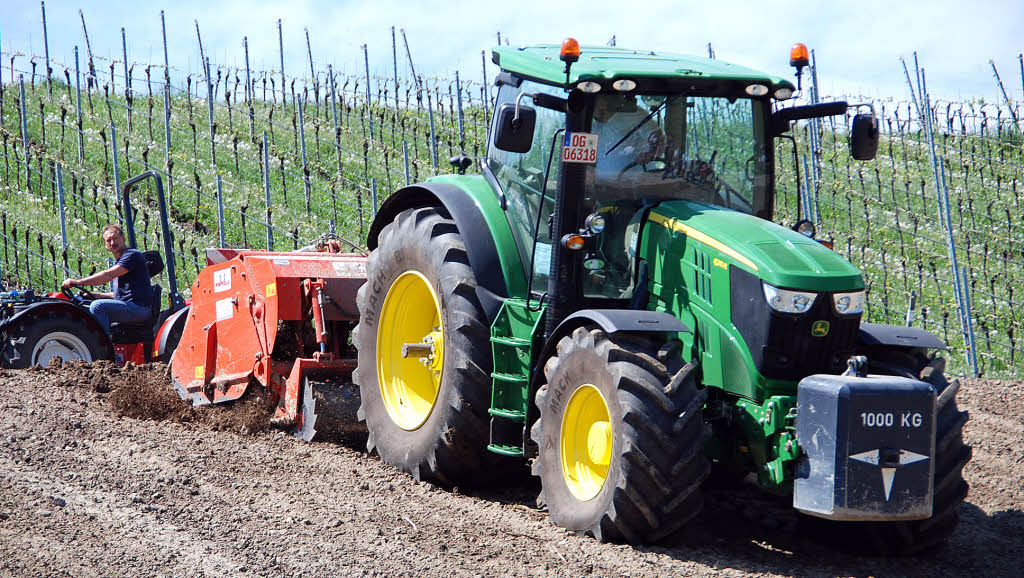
[583, 93, 771, 298]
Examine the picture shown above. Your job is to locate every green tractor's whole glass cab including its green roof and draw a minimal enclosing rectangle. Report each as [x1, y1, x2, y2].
[482, 39, 877, 335]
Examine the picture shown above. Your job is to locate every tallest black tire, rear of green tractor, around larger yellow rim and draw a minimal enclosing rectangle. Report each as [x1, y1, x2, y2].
[352, 207, 502, 487]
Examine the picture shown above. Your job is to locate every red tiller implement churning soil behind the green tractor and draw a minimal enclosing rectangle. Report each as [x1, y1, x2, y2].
[171, 245, 367, 441]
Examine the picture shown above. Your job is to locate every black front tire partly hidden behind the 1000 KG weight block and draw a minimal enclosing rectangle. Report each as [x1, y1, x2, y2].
[801, 349, 972, 555]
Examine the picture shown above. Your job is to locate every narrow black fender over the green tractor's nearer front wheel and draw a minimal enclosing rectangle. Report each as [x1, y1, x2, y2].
[523, 309, 692, 448]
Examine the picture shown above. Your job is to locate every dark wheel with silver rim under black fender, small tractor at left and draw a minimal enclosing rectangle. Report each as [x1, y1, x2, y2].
[2, 305, 111, 369]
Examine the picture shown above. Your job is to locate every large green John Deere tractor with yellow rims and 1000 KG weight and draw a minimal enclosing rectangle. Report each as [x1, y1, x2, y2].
[352, 39, 971, 553]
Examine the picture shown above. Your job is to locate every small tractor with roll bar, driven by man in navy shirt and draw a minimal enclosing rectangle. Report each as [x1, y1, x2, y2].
[0, 171, 187, 369]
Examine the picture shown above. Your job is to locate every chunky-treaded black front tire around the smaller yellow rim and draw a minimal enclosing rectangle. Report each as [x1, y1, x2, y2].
[531, 328, 711, 544]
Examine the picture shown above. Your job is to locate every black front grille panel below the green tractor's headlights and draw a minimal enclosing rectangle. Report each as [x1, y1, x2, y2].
[731, 267, 861, 381]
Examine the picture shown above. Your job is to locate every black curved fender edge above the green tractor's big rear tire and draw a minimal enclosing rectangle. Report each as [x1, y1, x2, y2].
[367, 182, 509, 323]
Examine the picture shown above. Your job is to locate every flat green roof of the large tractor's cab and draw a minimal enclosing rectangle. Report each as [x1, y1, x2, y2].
[492, 44, 793, 90]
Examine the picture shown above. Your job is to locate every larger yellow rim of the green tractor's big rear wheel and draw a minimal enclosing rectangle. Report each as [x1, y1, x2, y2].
[377, 271, 444, 431]
